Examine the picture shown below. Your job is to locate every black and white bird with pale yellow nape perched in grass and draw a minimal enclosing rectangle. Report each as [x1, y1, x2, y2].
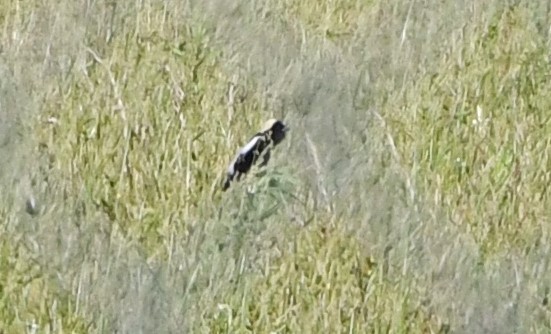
[222, 118, 289, 191]
